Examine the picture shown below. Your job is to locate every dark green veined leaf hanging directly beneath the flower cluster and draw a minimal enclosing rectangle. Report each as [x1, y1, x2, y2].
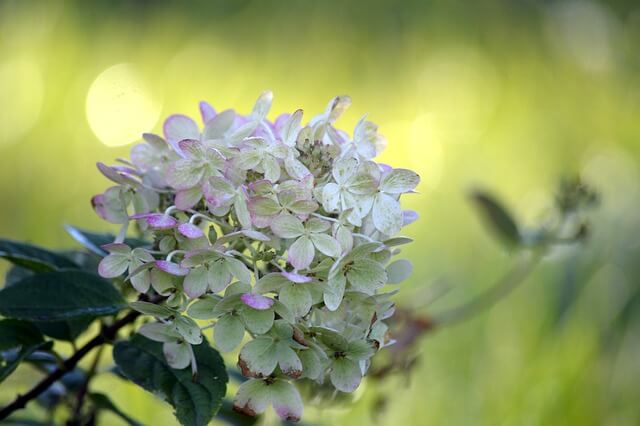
[113, 335, 229, 426]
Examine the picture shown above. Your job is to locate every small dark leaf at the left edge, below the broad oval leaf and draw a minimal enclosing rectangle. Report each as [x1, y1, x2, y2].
[0, 319, 51, 382]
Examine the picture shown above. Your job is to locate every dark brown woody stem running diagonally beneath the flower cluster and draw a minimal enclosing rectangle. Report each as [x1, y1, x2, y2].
[0, 311, 140, 420]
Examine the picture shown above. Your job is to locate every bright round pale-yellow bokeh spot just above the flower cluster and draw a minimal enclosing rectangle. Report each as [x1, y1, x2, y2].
[86, 64, 161, 146]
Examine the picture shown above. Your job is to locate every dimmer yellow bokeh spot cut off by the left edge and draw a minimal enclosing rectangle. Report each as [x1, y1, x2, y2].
[0, 59, 44, 147]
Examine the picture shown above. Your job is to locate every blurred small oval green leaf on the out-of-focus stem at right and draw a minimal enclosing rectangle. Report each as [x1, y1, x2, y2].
[470, 191, 521, 247]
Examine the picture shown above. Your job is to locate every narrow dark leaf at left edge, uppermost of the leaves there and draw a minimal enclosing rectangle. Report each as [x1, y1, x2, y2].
[0, 239, 78, 272]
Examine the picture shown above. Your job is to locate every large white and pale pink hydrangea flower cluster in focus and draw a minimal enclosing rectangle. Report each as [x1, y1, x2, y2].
[92, 92, 419, 421]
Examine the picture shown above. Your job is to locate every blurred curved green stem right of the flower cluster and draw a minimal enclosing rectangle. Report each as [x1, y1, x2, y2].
[432, 252, 542, 328]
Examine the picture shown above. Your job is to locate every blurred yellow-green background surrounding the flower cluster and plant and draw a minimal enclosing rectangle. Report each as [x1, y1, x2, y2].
[0, 0, 640, 426]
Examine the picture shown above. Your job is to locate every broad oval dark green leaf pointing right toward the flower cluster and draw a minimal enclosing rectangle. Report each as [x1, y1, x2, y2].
[0, 271, 127, 321]
